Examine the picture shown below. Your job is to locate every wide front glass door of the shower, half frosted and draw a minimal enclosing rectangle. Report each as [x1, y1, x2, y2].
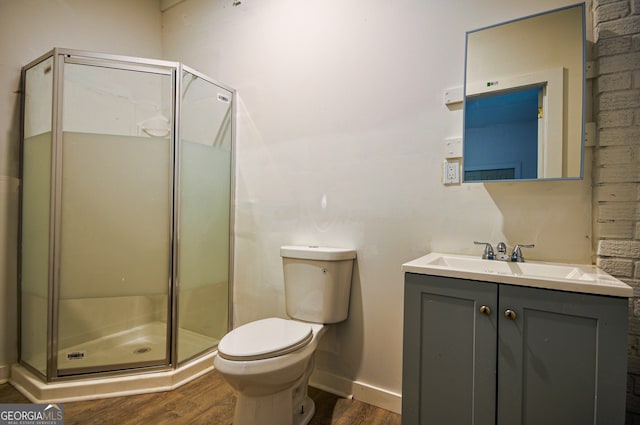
[55, 56, 175, 376]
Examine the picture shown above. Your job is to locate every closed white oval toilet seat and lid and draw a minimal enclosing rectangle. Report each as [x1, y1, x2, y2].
[218, 317, 313, 361]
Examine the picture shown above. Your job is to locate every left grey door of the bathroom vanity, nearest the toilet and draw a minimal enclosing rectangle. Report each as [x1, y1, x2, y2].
[402, 273, 497, 425]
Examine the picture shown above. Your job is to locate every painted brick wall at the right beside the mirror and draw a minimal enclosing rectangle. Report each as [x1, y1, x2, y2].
[592, 0, 640, 424]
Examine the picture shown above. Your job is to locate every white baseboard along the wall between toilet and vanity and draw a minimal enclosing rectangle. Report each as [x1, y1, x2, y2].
[309, 369, 402, 414]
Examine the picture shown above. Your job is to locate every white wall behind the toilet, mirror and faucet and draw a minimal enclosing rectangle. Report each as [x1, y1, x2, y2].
[162, 0, 592, 410]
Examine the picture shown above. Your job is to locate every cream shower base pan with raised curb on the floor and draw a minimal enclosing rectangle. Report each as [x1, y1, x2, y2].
[9, 324, 217, 403]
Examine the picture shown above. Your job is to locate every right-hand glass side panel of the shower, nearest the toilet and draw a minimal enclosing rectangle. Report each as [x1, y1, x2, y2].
[178, 71, 232, 362]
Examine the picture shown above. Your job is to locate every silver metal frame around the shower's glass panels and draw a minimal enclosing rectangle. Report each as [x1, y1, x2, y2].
[17, 48, 236, 382]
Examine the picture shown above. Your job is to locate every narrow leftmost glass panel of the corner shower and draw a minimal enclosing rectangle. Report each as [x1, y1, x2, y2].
[20, 54, 53, 373]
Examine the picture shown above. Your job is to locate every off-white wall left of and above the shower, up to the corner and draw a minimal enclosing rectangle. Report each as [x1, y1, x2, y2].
[0, 0, 162, 381]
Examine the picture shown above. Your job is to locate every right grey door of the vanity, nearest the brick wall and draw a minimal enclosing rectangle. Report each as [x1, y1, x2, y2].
[497, 285, 627, 425]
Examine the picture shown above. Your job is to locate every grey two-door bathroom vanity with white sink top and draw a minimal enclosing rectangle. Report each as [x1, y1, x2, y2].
[402, 253, 633, 425]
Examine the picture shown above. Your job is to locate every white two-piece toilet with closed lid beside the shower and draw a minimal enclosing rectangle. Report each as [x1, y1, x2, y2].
[214, 246, 356, 425]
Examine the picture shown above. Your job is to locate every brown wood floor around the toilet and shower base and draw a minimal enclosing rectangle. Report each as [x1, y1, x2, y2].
[0, 370, 400, 425]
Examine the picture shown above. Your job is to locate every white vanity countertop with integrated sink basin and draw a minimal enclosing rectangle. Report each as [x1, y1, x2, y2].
[402, 252, 633, 297]
